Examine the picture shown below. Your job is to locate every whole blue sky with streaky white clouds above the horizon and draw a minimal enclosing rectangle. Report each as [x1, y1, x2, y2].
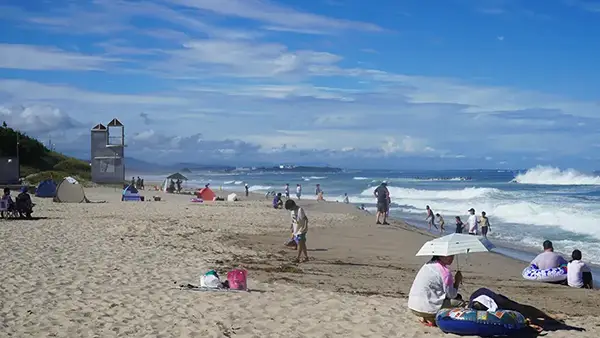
[0, 0, 600, 169]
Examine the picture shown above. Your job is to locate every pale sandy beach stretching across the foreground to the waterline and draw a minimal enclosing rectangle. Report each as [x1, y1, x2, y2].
[0, 187, 600, 338]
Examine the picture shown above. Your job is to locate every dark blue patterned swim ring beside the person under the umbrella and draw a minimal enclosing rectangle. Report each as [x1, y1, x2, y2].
[435, 308, 527, 337]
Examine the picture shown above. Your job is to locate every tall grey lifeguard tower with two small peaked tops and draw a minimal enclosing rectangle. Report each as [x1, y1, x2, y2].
[90, 118, 125, 184]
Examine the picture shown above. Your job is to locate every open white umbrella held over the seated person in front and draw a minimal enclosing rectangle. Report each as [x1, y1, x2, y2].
[417, 233, 494, 256]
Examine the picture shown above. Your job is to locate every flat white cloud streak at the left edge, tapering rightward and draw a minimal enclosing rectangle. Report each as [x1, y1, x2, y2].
[0, 44, 119, 70]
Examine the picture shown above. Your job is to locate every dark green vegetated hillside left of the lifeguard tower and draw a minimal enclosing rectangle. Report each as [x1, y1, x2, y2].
[0, 122, 91, 184]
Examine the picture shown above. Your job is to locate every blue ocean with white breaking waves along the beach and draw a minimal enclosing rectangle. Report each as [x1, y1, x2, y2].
[136, 167, 600, 264]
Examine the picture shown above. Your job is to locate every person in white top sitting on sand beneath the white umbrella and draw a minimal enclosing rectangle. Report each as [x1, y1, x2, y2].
[408, 256, 465, 326]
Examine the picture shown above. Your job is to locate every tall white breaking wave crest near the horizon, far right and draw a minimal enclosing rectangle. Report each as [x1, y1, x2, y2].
[513, 166, 600, 185]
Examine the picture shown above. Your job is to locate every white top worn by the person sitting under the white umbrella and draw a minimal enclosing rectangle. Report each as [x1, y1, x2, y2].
[408, 263, 458, 314]
